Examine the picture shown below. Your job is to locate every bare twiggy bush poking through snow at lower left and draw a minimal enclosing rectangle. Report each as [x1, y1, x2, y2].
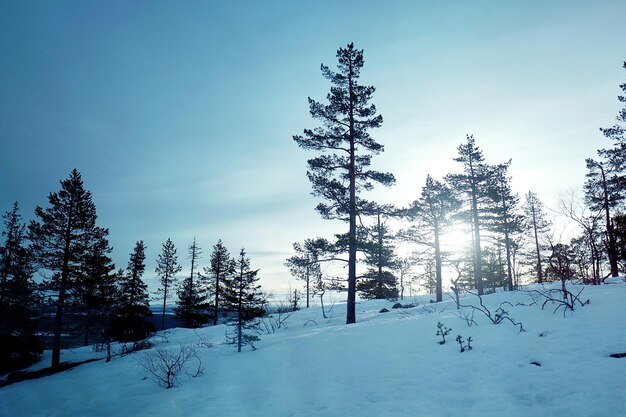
[139, 346, 204, 389]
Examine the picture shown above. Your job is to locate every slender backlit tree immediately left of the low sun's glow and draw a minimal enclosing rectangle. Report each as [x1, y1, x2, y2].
[406, 175, 461, 302]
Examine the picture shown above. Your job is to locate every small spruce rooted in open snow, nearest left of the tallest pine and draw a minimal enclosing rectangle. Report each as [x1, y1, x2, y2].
[223, 248, 266, 352]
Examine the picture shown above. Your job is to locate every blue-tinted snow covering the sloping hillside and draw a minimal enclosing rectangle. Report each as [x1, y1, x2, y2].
[0, 279, 626, 417]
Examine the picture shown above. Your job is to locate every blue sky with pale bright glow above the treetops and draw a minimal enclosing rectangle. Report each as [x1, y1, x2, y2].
[0, 0, 626, 298]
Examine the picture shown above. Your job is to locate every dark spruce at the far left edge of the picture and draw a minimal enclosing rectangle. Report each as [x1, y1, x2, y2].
[0, 202, 43, 372]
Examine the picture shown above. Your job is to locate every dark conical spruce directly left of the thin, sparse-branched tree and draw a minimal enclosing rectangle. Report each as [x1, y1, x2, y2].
[111, 240, 155, 342]
